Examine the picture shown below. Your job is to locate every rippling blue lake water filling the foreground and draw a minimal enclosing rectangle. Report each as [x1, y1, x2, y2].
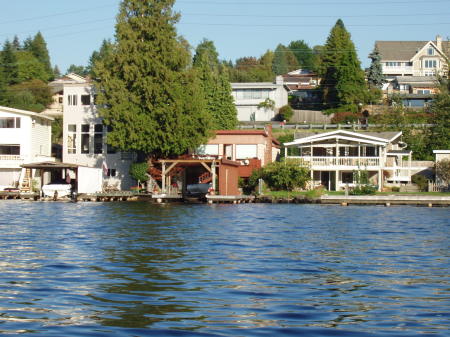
[0, 200, 450, 337]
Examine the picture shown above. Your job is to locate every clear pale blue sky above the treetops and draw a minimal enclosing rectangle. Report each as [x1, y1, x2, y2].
[0, 0, 450, 73]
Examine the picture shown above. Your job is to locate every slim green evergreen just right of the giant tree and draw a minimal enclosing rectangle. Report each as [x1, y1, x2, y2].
[193, 40, 238, 130]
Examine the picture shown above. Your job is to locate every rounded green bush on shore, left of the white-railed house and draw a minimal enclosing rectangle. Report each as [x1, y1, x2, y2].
[262, 159, 310, 191]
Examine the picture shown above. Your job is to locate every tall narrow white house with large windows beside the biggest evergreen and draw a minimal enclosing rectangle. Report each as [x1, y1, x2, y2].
[62, 78, 134, 190]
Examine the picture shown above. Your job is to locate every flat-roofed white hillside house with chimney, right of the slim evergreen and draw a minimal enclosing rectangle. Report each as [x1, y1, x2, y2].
[231, 76, 288, 122]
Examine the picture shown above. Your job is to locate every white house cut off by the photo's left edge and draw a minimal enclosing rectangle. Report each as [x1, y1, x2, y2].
[0, 106, 55, 189]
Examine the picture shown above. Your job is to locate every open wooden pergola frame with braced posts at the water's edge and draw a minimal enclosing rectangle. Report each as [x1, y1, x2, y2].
[158, 159, 218, 193]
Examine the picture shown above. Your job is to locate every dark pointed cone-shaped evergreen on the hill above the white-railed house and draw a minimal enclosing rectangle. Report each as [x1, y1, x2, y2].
[319, 19, 367, 109]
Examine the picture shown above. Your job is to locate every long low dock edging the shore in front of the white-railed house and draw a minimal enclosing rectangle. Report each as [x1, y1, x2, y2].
[320, 194, 450, 207]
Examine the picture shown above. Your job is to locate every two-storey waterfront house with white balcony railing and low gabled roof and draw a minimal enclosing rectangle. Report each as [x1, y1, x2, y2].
[284, 130, 414, 191]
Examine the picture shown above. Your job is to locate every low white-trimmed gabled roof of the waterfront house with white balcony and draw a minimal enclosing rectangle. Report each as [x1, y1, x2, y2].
[284, 130, 402, 146]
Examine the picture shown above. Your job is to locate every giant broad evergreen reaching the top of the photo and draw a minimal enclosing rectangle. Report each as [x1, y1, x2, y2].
[95, 0, 211, 157]
